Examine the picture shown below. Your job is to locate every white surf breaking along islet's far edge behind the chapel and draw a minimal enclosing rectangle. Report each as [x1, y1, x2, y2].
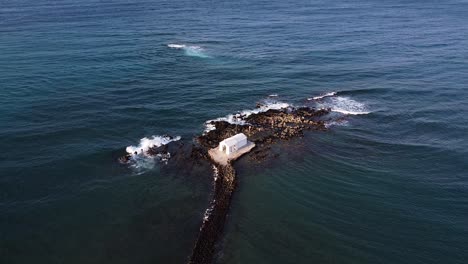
[205, 101, 290, 133]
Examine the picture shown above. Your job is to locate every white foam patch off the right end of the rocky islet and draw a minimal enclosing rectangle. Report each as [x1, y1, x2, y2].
[319, 96, 370, 115]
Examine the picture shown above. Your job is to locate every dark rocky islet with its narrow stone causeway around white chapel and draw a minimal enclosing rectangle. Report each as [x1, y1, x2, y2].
[119, 105, 331, 264]
